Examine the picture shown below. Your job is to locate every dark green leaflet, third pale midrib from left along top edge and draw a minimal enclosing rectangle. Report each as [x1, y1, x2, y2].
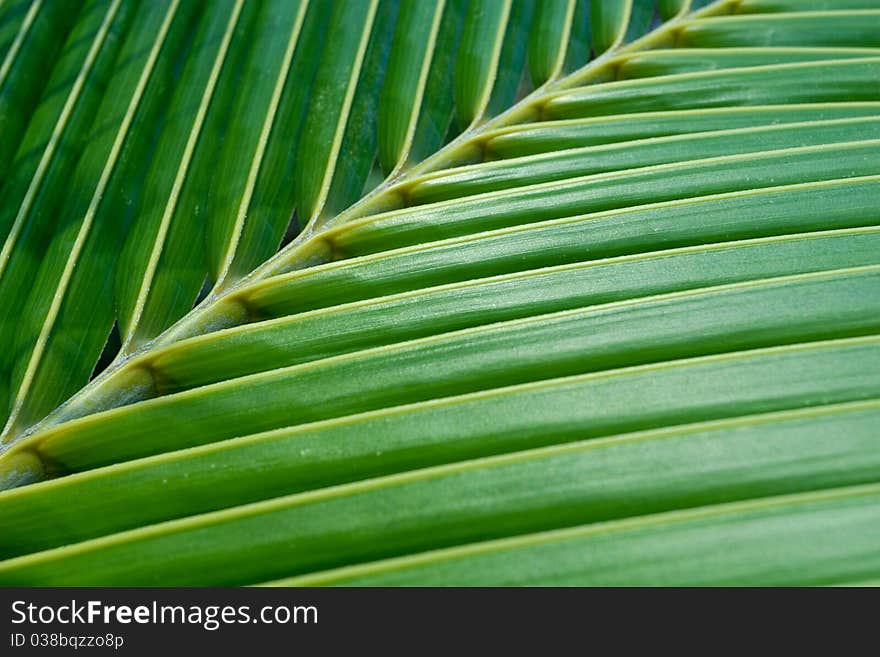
[1, 2, 199, 438]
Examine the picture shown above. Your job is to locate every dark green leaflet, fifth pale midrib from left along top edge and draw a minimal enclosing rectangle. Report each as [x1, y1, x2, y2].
[205, 0, 310, 285]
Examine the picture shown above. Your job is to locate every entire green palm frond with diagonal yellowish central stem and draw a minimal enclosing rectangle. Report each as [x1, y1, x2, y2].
[0, 0, 880, 585]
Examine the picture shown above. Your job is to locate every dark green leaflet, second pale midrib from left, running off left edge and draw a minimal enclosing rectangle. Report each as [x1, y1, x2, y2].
[0, 0, 134, 430]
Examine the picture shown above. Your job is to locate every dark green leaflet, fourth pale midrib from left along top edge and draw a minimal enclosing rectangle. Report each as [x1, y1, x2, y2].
[116, 0, 249, 353]
